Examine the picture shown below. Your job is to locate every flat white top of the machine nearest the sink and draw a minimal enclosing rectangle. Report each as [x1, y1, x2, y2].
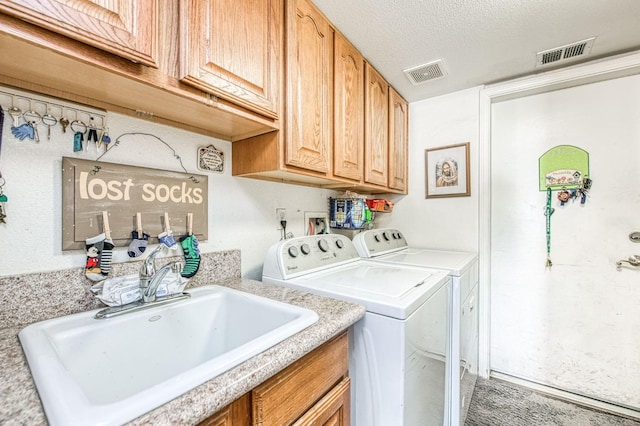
[290, 260, 448, 319]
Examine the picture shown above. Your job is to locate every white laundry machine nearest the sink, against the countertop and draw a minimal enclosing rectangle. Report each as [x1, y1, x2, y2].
[262, 234, 451, 426]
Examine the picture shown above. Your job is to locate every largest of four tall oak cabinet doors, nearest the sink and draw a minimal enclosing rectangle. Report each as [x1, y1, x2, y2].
[285, 0, 334, 173]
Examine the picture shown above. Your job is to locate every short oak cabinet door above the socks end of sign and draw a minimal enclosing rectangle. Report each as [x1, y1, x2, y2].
[180, 0, 283, 118]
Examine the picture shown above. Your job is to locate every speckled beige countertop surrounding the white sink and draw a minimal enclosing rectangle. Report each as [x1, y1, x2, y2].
[0, 278, 365, 425]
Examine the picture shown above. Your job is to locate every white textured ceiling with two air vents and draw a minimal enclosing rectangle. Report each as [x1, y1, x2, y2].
[312, 0, 640, 102]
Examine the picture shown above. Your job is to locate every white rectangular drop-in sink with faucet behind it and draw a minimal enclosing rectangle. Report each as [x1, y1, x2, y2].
[19, 285, 318, 425]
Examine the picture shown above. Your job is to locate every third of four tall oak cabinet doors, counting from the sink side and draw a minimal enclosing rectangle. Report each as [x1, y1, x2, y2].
[364, 63, 389, 187]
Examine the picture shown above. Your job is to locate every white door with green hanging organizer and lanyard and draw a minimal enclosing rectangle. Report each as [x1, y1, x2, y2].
[490, 75, 640, 410]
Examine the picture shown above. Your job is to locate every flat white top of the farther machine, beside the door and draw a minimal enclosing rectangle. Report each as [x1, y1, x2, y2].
[376, 248, 478, 277]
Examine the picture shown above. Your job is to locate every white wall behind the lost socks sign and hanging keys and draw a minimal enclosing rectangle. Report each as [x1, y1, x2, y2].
[0, 105, 335, 279]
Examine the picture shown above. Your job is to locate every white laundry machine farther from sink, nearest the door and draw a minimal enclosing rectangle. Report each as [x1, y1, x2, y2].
[353, 228, 478, 426]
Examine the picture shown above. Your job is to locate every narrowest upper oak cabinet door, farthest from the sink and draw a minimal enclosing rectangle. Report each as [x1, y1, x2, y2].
[389, 87, 409, 193]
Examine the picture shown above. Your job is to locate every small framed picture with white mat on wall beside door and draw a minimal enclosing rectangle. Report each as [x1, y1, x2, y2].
[425, 142, 471, 198]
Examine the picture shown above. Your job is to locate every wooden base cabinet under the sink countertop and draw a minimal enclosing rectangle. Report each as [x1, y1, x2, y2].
[200, 332, 350, 426]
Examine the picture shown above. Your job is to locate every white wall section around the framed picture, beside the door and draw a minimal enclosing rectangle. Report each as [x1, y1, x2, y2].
[376, 88, 480, 251]
